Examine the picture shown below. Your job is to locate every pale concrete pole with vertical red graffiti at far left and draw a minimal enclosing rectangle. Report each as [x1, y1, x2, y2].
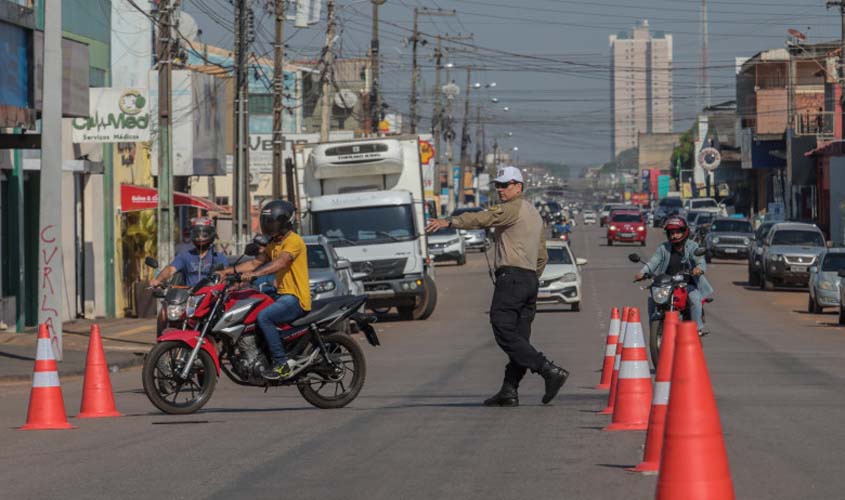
[39, 2, 65, 361]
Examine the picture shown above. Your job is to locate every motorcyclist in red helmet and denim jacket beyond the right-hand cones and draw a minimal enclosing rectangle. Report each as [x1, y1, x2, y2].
[634, 215, 713, 335]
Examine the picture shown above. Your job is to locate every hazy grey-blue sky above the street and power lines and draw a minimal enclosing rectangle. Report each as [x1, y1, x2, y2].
[183, 0, 839, 164]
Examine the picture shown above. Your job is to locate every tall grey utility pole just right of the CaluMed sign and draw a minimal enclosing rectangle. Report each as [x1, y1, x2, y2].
[156, 0, 178, 282]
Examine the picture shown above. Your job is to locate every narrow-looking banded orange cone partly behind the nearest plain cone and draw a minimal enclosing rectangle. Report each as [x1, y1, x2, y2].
[628, 311, 681, 474]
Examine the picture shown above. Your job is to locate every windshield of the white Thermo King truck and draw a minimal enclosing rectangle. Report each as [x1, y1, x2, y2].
[312, 205, 414, 246]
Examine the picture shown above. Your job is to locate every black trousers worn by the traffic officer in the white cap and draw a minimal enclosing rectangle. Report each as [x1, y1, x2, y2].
[490, 267, 546, 387]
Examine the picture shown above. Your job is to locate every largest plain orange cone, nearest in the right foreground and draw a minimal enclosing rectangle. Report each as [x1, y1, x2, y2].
[657, 321, 735, 500]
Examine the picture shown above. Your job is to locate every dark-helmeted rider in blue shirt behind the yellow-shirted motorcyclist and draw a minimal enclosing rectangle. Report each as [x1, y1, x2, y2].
[150, 217, 229, 287]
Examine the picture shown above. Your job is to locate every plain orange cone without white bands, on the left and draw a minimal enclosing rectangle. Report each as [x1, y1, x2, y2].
[77, 325, 122, 418]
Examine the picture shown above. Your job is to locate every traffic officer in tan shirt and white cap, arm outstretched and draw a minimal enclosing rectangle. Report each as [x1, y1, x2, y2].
[426, 166, 569, 406]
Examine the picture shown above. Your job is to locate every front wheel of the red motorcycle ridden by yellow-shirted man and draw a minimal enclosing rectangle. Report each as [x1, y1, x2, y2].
[141, 342, 217, 415]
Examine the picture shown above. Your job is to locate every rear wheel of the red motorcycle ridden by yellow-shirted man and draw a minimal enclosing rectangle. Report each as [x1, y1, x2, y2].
[296, 333, 367, 409]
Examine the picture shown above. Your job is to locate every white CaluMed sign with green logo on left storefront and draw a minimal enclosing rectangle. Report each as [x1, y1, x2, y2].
[71, 87, 150, 143]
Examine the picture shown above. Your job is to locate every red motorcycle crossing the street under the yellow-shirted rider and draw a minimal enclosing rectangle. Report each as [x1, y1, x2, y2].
[142, 243, 379, 414]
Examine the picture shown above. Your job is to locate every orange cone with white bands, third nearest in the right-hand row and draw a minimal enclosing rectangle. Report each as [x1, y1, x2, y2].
[604, 308, 652, 431]
